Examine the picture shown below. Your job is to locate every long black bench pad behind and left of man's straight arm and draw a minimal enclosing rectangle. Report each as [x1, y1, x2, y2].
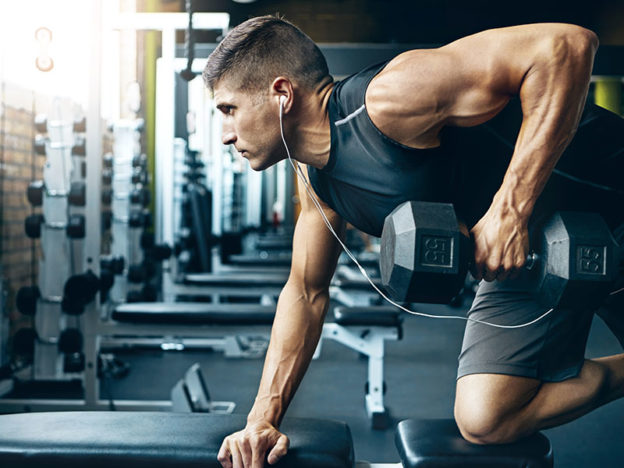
[112, 302, 275, 325]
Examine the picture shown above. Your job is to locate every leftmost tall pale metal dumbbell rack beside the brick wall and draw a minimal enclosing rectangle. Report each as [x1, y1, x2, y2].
[32, 113, 85, 380]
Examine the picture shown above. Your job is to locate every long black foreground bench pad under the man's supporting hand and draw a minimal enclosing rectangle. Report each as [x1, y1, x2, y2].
[0, 412, 354, 468]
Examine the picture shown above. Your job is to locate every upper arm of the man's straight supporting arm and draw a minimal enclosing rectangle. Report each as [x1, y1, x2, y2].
[288, 166, 344, 292]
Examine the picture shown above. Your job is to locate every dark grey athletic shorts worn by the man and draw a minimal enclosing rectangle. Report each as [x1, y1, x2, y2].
[457, 226, 624, 382]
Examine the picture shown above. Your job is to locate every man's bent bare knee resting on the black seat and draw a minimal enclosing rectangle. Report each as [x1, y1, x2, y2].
[455, 374, 539, 444]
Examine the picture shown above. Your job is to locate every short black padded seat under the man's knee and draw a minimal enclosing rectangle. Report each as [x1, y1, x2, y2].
[395, 419, 553, 468]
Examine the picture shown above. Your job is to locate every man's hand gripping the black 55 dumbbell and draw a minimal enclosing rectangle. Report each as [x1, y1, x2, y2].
[470, 205, 529, 281]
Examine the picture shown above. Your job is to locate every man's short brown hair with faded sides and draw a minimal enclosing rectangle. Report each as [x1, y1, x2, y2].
[202, 15, 329, 91]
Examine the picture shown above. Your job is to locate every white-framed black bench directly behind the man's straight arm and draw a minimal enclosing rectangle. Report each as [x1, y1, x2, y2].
[111, 302, 403, 429]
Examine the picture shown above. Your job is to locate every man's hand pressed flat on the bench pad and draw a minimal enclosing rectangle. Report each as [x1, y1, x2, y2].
[217, 421, 290, 468]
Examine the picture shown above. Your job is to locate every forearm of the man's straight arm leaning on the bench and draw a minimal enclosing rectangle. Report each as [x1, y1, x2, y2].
[247, 284, 329, 427]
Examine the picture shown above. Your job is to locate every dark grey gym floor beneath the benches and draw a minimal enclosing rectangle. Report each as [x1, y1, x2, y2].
[109, 305, 624, 468]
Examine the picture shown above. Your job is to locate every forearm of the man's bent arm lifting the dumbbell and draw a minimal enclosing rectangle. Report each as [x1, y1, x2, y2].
[493, 30, 597, 222]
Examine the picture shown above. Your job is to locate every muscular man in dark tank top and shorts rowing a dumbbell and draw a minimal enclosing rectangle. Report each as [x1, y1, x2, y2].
[204, 16, 624, 468]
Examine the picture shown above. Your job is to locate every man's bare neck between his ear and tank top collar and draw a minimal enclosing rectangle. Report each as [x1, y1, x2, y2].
[284, 82, 334, 169]
